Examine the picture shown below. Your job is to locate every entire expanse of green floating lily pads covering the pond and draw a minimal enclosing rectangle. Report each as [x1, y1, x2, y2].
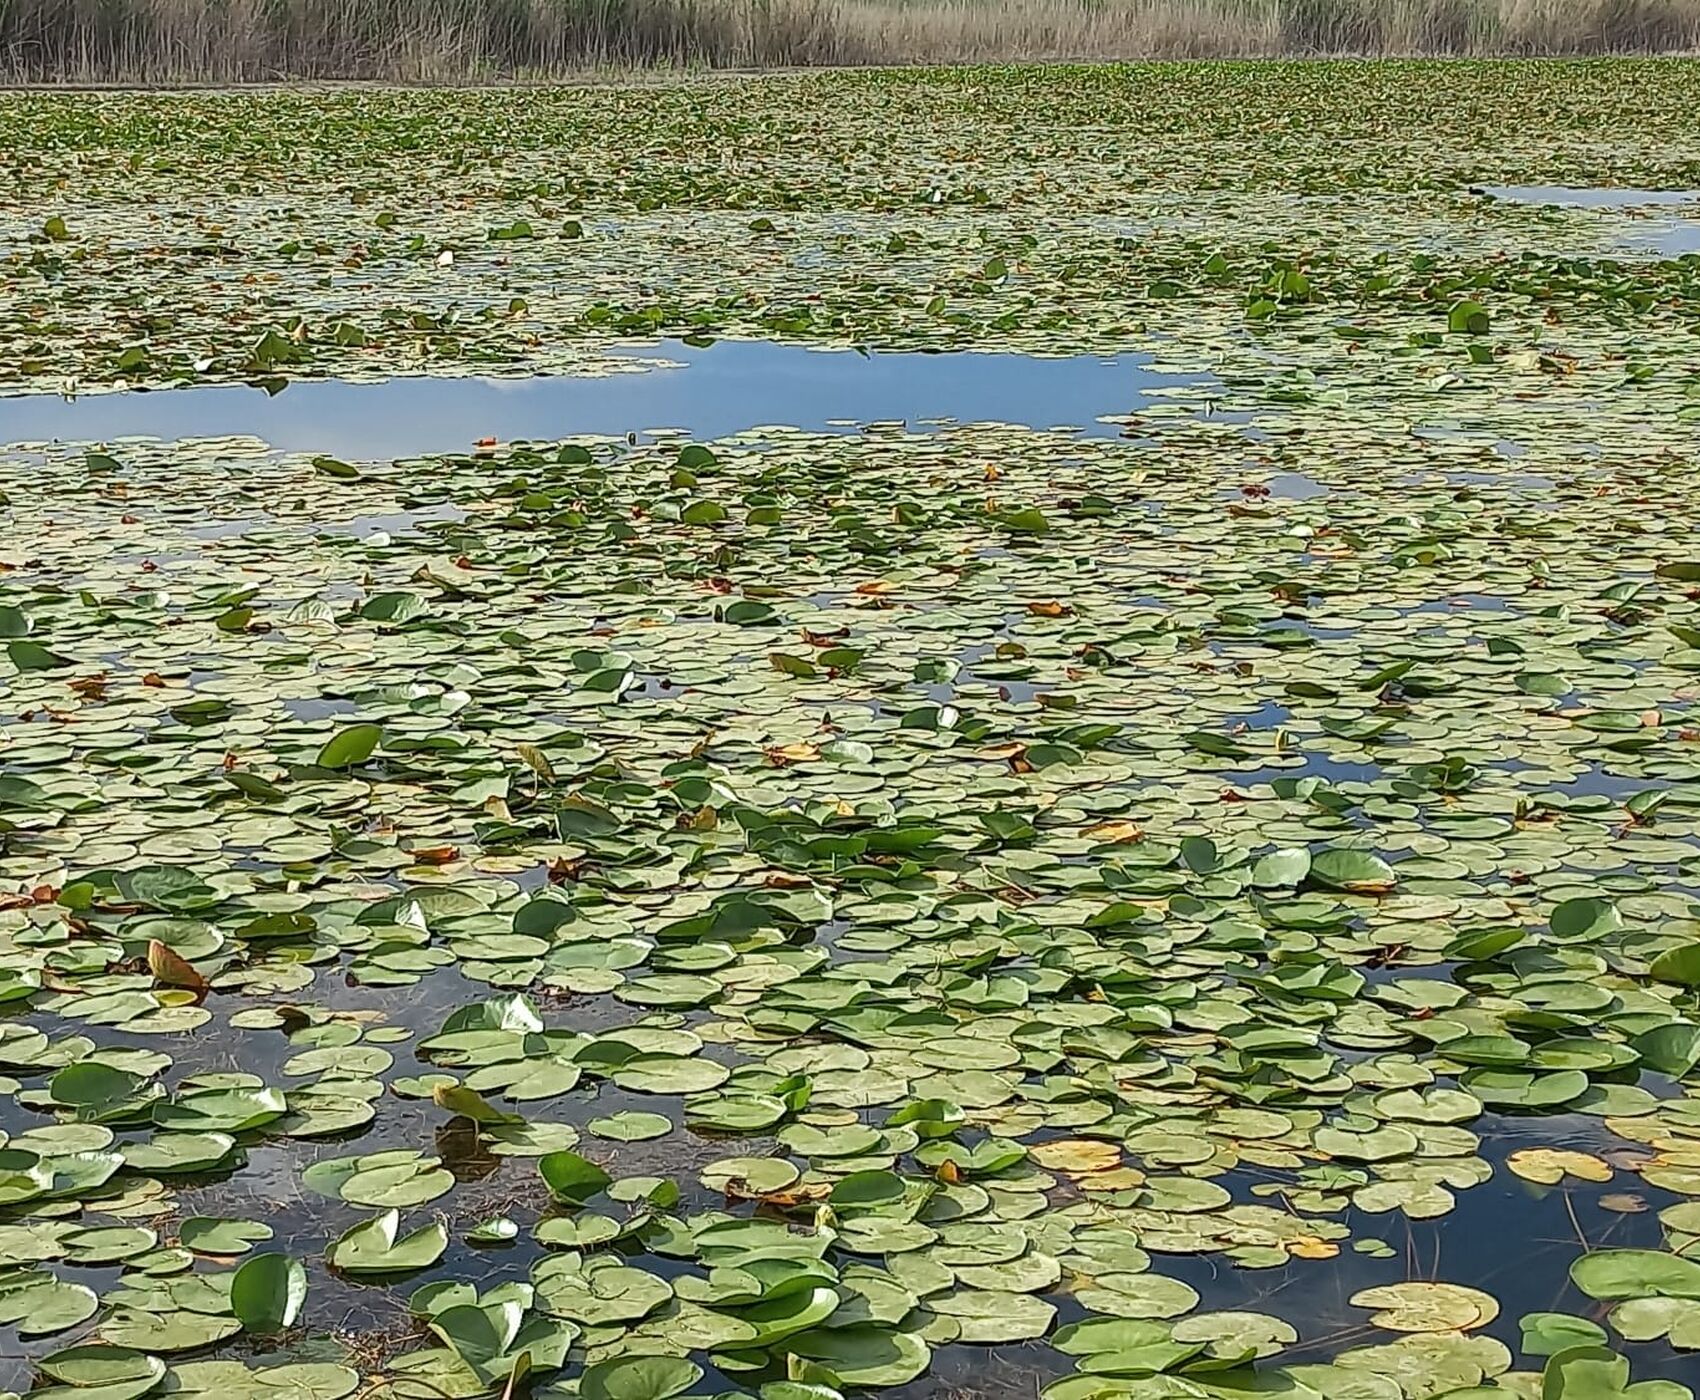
[0, 65, 1700, 1400]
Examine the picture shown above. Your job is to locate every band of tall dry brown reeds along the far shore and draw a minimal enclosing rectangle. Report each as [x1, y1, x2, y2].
[0, 0, 1700, 83]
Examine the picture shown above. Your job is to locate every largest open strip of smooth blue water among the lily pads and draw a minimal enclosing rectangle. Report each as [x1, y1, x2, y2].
[0, 340, 1216, 457]
